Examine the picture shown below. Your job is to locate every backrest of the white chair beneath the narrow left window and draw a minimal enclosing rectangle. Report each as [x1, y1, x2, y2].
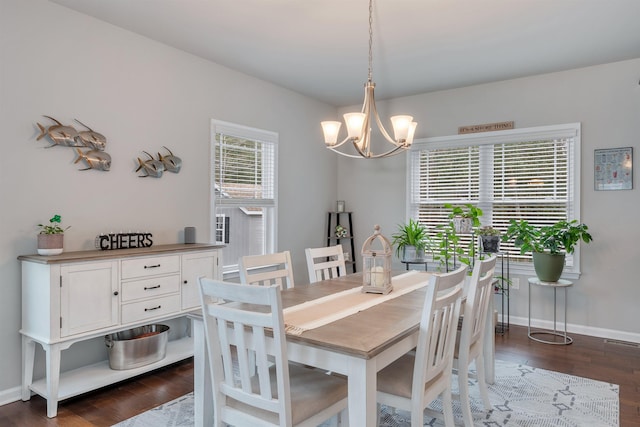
[238, 251, 293, 289]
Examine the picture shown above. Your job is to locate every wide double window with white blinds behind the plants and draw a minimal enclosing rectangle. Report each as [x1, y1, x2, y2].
[408, 123, 580, 274]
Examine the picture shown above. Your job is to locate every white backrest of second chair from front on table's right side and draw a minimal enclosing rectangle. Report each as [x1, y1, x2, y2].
[458, 255, 496, 357]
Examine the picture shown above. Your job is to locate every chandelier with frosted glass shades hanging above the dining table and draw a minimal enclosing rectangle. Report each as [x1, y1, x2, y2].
[321, 0, 418, 159]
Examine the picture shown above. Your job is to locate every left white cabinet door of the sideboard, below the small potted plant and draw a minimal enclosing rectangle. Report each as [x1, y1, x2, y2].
[60, 262, 119, 337]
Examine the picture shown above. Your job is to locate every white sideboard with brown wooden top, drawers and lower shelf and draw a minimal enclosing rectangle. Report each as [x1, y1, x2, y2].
[18, 243, 222, 417]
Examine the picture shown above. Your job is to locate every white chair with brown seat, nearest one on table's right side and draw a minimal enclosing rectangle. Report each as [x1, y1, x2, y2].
[376, 265, 467, 427]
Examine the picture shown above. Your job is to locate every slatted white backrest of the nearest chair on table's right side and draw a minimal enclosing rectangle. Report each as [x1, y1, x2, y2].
[412, 265, 467, 392]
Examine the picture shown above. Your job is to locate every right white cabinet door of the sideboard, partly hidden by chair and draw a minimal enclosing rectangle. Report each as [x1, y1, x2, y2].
[182, 251, 220, 310]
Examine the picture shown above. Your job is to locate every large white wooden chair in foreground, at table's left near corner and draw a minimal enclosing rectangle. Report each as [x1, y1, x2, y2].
[199, 277, 347, 427]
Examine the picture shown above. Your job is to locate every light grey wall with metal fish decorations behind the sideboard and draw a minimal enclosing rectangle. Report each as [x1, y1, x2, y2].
[0, 0, 337, 404]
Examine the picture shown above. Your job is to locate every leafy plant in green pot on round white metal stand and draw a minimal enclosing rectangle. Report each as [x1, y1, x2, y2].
[502, 219, 593, 282]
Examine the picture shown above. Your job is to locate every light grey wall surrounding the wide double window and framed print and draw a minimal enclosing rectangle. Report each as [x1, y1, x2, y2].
[338, 59, 640, 342]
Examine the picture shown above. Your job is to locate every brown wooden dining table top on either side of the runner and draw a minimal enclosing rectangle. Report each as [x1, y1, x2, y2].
[281, 272, 428, 359]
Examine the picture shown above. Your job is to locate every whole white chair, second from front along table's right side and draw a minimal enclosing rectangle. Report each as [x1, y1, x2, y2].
[453, 255, 496, 427]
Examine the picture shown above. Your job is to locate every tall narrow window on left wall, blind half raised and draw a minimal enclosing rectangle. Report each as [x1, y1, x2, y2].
[210, 120, 278, 275]
